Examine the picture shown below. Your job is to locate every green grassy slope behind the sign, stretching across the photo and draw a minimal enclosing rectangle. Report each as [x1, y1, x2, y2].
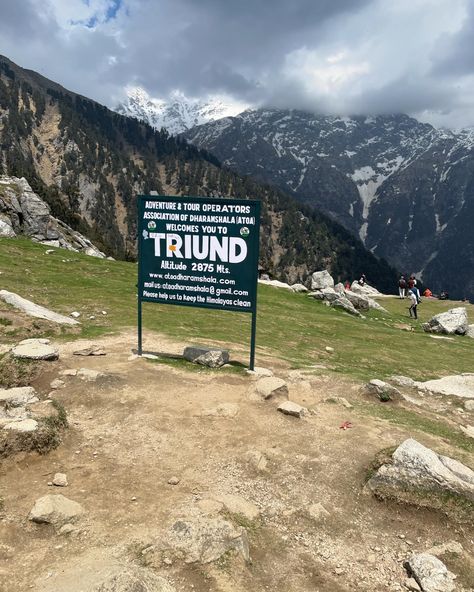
[0, 239, 474, 380]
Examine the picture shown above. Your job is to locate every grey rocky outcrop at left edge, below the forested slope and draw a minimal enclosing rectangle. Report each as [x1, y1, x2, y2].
[0, 175, 105, 258]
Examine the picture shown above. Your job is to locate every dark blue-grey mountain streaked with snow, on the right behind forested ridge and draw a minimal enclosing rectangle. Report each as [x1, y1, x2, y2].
[185, 108, 474, 298]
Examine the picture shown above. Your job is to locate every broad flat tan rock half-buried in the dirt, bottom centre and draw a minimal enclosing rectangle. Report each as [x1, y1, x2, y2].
[162, 516, 249, 563]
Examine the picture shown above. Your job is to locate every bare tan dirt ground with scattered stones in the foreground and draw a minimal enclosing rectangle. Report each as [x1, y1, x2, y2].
[0, 332, 474, 592]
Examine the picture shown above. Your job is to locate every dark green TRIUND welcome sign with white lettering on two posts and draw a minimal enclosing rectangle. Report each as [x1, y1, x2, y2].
[137, 195, 260, 370]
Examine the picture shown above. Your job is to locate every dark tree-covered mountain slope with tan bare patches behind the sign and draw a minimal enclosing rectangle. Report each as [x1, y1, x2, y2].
[0, 57, 396, 291]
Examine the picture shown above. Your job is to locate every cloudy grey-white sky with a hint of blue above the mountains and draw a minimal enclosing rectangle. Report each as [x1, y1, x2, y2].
[0, 0, 474, 127]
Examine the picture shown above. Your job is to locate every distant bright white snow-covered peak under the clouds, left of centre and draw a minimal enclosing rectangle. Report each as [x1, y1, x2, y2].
[115, 87, 247, 135]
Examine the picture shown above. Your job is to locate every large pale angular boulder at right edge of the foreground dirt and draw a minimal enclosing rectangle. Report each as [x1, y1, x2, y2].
[367, 438, 474, 507]
